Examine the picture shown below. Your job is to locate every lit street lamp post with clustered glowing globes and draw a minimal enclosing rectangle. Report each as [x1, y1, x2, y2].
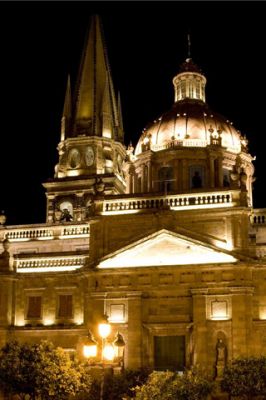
[83, 315, 125, 400]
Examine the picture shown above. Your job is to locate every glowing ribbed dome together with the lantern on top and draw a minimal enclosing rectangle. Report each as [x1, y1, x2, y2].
[135, 58, 243, 155]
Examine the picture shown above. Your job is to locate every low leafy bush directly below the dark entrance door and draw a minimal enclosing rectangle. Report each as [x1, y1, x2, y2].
[131, 369, 212, 400]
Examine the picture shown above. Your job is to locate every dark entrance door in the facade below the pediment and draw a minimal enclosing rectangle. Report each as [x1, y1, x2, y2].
[154, 336, 185, 371]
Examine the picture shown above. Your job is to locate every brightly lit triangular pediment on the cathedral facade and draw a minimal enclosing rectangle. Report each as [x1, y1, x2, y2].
[98, 229, 237, 268]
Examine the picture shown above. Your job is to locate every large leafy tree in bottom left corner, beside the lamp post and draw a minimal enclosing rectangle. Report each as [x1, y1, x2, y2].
[0, 341, 91, 400]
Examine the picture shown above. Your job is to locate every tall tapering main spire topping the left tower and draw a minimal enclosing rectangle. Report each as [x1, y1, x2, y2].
[74, 15, 123, 139]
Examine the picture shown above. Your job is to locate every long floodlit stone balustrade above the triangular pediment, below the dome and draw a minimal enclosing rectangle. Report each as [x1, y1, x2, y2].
[103, 190, 239, 214]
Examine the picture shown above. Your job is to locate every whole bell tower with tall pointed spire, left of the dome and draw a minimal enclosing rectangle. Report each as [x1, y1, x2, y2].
[43, 15, 126, 222]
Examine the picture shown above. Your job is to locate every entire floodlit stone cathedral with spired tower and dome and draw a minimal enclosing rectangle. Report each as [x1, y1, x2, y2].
[0, 16, 266, 377]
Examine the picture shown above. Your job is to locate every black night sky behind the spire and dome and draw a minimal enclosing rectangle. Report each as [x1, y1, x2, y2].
[0, 1, 266, 225]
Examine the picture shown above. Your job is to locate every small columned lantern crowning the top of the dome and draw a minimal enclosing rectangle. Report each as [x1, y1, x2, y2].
[173, 58, 206, 103]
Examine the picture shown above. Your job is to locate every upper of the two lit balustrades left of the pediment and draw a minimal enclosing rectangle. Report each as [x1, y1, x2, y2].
[4, 224, 90, 242]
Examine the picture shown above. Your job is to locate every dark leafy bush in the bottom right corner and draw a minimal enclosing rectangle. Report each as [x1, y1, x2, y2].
[221, 357, 266, 399]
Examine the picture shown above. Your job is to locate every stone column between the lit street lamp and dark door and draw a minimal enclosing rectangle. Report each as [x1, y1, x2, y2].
[125, 292, 142, 369]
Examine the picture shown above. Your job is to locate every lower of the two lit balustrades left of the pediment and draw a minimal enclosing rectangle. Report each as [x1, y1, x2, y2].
[15, 256, 86, 272]
